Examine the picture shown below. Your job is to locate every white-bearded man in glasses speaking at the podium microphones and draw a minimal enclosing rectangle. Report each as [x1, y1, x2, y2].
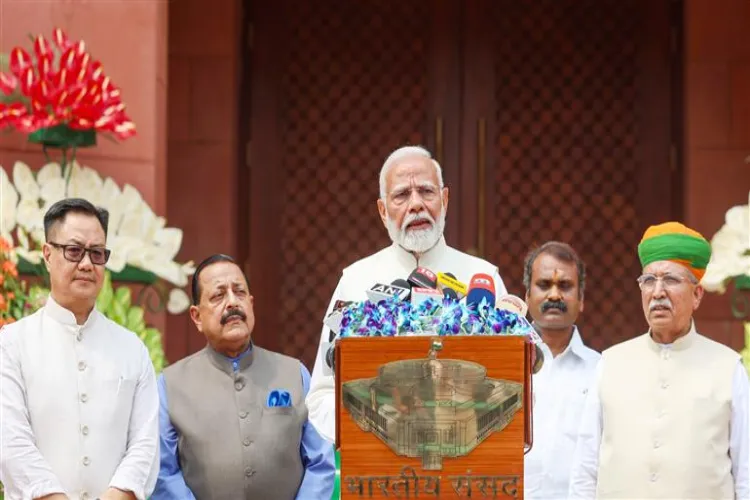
[307, 146, 507, 442]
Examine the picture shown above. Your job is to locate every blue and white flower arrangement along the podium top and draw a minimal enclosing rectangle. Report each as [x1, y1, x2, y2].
[339, 298, 538, 343]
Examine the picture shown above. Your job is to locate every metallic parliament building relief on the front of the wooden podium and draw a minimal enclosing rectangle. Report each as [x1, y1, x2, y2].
[343, 350, 523, 470]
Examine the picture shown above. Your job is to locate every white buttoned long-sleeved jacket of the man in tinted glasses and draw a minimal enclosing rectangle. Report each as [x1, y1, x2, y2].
[0, 297, 159, 500]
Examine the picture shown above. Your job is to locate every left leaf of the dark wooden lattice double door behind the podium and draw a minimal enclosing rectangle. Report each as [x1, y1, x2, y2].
[247, 0, 460, 366]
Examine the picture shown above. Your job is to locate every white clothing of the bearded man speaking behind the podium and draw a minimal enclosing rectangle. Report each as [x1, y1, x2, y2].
[306, 237, 507, 442]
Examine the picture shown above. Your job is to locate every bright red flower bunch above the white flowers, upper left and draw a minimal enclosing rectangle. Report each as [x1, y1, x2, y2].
[0, 28, 136, 147]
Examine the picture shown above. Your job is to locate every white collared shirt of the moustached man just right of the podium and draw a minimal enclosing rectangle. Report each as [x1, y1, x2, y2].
[524, 328, 601, 500]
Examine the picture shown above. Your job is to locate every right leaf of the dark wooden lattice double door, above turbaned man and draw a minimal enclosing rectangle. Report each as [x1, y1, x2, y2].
[461, 0, 680, 349]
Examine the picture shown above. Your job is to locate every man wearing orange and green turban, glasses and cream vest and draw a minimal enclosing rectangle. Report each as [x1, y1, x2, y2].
[569, 222, 750, 499]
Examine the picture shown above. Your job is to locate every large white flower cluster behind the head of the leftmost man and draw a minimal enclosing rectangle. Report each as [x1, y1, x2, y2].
[0, 160, 195, 314]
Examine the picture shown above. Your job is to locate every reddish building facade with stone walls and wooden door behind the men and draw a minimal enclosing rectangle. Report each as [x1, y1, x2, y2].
[0, 0, 750, 365]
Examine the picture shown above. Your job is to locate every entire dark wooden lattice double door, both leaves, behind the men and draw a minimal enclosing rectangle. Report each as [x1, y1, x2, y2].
[247, 0, 679, 366]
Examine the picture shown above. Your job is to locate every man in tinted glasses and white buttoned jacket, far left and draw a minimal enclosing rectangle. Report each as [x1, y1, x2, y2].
[0, 198, 159, 500]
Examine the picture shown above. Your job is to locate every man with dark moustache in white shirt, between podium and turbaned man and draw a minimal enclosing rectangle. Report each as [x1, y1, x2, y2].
[523, 241, 600, 500]
